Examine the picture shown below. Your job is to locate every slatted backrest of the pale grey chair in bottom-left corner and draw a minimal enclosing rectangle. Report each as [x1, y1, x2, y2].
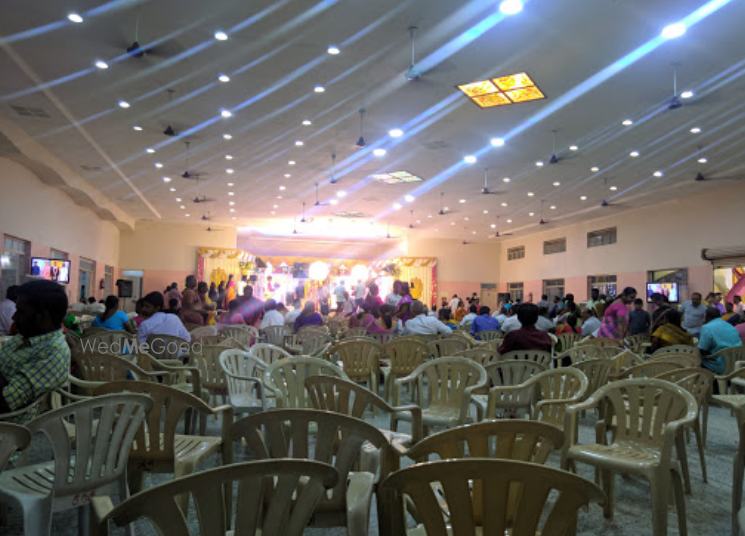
[27, 394, 153, 496]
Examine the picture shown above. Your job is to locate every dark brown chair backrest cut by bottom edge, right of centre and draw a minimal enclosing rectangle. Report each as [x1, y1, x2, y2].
[379, 458, 605, 536]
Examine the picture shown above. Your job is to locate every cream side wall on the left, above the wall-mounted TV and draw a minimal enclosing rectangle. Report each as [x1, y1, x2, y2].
[0, 158, 120, 301]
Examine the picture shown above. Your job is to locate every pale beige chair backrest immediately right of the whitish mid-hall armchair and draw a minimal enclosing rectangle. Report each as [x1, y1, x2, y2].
[264, 357, 349, 408]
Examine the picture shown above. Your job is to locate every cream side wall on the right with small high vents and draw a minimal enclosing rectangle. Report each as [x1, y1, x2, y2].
[500, 183, 745, 301]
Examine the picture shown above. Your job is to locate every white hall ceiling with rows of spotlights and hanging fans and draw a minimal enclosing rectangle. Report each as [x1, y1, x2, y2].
[0, 0, 745, 240]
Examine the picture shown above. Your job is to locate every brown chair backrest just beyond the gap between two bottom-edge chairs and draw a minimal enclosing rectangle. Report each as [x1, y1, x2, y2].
[232, 409, 391, 511]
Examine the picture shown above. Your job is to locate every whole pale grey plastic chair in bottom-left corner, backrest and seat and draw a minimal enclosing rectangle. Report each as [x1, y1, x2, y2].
[0, 394, 153, 536]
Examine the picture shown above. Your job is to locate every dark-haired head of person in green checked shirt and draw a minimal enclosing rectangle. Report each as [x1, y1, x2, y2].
[13, 280, 68, 338]
